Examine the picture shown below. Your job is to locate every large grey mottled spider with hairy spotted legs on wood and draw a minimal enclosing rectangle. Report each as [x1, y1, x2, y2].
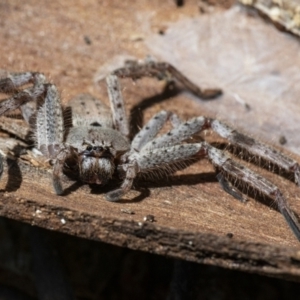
[0, 61, 300, 240]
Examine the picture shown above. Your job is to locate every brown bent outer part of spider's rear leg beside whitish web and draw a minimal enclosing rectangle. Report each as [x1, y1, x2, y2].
[112, 60, 222, 99]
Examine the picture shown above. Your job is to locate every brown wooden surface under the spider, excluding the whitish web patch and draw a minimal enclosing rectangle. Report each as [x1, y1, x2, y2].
[0, 0, 300, 280]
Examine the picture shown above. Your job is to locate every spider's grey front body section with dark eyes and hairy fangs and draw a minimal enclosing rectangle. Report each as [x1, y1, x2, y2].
[65, 125, 130, 184]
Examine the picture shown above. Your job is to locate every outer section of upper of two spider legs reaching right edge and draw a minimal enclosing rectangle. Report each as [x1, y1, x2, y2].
[210, 119, 300, 186]
